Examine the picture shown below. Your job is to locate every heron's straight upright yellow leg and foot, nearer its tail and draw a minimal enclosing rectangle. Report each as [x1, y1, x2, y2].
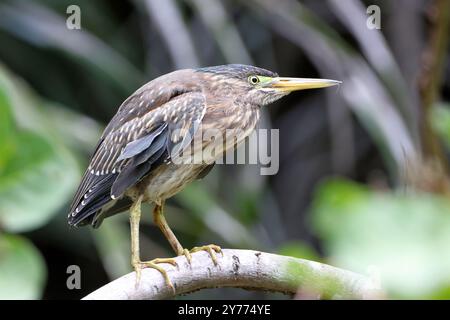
[130, 196, 177, 292]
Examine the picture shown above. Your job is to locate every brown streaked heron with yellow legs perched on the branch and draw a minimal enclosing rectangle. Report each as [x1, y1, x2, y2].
[68, 64, 341, 291]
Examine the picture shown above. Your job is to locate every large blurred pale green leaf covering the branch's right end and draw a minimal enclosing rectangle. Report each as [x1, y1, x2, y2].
[313, 180, 450, 298]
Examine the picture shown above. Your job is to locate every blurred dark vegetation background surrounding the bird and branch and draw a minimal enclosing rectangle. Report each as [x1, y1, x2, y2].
[0, 0, 450, 299]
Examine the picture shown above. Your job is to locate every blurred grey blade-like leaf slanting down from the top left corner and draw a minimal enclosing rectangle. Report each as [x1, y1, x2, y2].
[0, 1, 143, 91]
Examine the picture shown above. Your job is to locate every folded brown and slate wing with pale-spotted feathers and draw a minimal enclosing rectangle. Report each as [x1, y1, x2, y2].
[68, 92, 206, 225]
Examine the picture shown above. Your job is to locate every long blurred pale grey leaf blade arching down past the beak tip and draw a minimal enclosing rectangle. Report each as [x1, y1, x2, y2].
[251, 0, 418, 180]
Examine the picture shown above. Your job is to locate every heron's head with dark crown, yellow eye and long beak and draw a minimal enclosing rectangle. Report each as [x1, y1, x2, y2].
[197, 64, 341, 105]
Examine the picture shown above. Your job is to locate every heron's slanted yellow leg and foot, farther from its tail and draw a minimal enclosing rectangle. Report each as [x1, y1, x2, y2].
[153, 203, 222, 265]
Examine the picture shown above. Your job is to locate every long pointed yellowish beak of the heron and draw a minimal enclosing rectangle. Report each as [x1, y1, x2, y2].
[267, 77, 342, 92]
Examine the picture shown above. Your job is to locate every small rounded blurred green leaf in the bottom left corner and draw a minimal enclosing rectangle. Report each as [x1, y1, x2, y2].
[0, 234, 46, 300]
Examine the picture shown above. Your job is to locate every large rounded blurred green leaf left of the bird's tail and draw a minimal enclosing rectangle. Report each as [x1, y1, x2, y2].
[0, 132, 78, 232]
